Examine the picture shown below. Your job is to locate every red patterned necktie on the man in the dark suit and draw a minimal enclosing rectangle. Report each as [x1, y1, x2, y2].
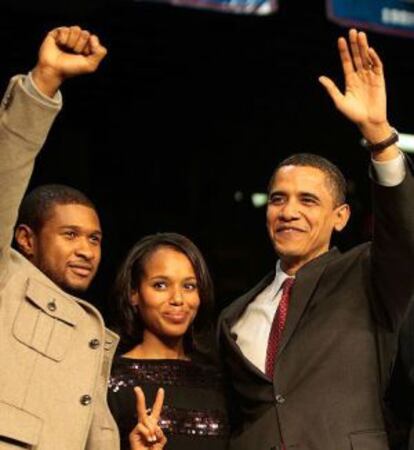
[265, 277, 295, 379]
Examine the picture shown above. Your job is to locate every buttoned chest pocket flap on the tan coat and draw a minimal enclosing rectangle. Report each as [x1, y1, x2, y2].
[26, 278, 79, 326]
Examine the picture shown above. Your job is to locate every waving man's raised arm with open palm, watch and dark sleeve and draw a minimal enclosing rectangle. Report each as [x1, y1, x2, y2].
[319, 30, 414, 329]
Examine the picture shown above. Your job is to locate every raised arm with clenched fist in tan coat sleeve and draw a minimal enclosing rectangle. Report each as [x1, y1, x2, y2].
[0, 26, 106, 280]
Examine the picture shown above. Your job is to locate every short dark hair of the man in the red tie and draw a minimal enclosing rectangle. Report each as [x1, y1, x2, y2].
[268, 153, 347, 206]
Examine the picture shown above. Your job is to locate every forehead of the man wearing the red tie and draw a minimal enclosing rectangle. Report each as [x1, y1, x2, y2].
[270, 166, 332, 197]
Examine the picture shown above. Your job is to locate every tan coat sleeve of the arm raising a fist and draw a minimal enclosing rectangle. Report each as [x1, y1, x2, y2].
[0, 76, 60, 283]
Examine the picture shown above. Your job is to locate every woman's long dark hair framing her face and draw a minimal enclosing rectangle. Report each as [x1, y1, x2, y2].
[113, 233, 214, 354]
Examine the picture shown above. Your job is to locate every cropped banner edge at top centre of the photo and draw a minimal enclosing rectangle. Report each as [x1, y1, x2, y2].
[135, 0, 279, 16]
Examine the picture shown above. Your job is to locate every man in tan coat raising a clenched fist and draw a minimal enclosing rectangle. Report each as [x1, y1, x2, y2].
[0, 27, 119, 450]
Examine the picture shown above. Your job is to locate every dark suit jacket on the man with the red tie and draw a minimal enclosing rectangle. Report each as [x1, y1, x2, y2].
[219, 164, 414, 450]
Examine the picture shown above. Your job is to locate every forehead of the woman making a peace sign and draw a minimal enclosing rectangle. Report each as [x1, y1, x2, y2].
[145, 247, 194, 275]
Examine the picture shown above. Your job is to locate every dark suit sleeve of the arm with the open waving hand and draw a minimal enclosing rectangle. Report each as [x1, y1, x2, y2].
[371, 159, 414, 329]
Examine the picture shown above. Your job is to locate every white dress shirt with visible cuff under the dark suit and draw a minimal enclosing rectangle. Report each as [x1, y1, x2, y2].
[231, 153, 405, 373]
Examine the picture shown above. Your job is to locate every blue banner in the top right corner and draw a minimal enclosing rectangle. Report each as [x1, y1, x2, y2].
[326, 0, 414, 37]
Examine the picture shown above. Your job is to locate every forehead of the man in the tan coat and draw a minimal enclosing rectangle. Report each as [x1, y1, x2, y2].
[43, 203, 101, 231]
